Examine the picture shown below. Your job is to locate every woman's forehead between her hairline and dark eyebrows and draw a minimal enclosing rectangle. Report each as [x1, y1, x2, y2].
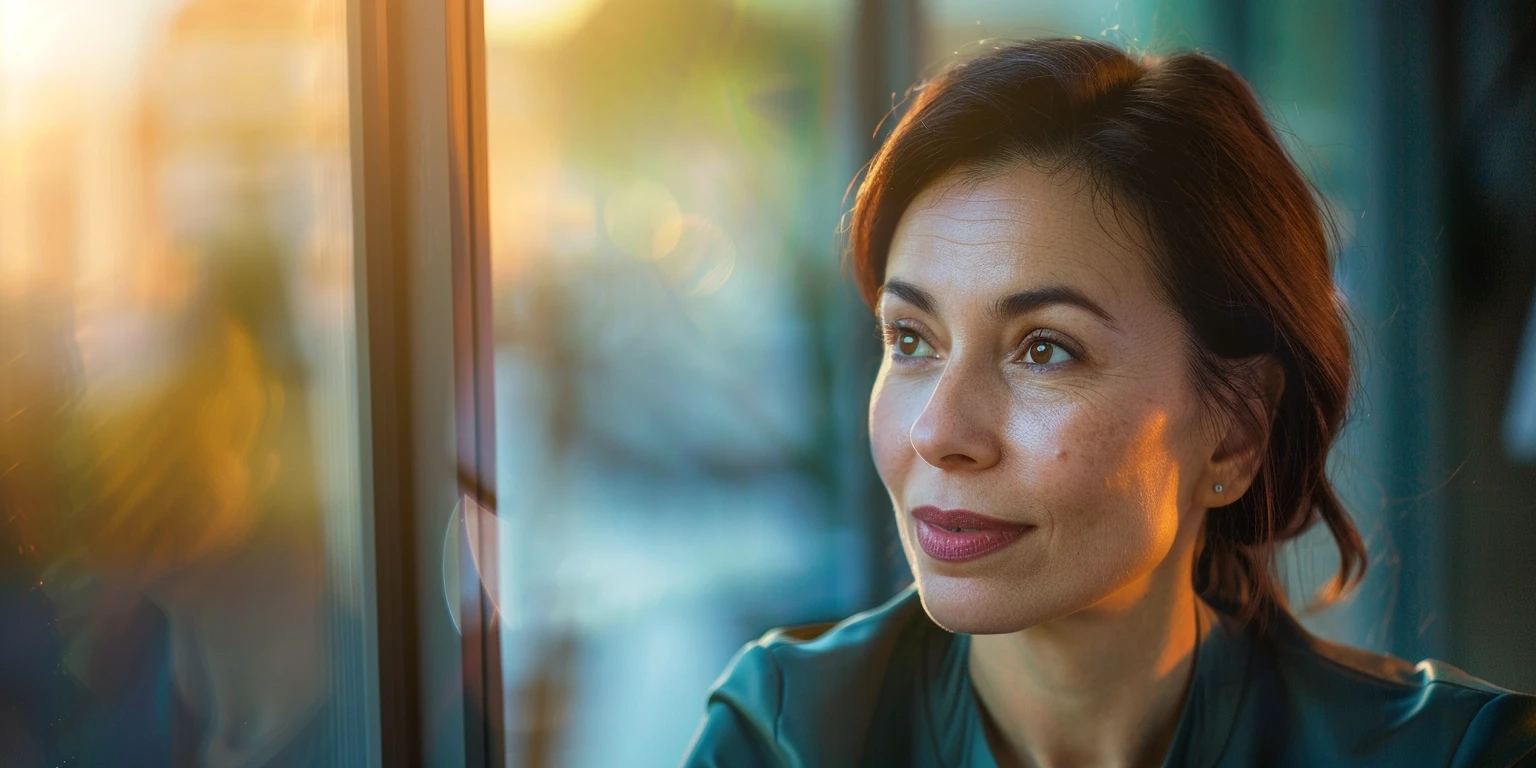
[885, 166, 1154, 304]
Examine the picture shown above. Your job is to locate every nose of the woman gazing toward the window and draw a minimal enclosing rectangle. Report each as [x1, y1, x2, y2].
[911, 358, 1008, 472]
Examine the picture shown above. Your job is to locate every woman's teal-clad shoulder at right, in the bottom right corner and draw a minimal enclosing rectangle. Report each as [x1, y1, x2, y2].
[1247, 625, 1536, 766]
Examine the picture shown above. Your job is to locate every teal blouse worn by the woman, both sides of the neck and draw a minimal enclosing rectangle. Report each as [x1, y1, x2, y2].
[685, 588, 1536, 768]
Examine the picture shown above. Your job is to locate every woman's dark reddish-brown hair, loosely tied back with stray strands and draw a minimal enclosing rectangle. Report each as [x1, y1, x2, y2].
[848, 40, 1366, 621]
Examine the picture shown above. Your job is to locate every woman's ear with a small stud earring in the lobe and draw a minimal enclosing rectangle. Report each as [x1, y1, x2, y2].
[1195, 355, 1286, 508]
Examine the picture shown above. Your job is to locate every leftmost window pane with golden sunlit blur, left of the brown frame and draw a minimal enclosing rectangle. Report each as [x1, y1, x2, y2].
[0, 0, 373, 765]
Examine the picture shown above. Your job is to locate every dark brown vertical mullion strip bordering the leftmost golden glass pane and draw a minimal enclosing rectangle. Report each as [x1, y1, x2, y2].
[347, 0, 422, 766]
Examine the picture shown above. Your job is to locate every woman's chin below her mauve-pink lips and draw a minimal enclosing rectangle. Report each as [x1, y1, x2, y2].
[917, 570, 1087, 634]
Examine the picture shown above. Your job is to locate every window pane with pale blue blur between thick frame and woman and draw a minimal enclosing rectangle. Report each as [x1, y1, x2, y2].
[485, 0, 866, 766]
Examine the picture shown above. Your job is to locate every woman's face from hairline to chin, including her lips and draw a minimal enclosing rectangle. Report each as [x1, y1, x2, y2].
[869, 167, 1215, 634]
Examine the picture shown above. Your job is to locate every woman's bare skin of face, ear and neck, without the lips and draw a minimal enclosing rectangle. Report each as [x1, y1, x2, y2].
[869, 166, 1261, 765]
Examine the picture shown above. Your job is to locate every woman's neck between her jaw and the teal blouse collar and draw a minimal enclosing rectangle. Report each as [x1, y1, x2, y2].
[969, 543, 1200, 768]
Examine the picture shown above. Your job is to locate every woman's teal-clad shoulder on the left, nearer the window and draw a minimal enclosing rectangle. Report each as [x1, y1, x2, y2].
[685, 590, 942, 766]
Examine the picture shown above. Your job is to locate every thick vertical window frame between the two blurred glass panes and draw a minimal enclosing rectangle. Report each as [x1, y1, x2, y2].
[347, 0, 505, 766]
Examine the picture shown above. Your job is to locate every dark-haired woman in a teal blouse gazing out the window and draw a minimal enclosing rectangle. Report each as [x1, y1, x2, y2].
[688, 40, 1536, 766]
